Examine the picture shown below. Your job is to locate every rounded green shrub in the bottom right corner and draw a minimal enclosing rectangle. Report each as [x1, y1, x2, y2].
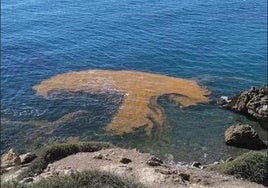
[215, 151, 268, 183]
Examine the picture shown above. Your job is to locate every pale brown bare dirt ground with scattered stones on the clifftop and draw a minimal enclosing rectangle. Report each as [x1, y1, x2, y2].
[35, 148, 264, 188]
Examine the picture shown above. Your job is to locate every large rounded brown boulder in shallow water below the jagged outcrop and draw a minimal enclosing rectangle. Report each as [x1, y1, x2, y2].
[224, 124, 267, 149]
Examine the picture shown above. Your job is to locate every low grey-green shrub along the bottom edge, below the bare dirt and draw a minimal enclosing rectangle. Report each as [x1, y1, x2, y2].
[1, 171, 144, 188]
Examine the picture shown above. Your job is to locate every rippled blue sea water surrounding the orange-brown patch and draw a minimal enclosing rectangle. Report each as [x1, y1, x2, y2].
[1, 0, 267, 162]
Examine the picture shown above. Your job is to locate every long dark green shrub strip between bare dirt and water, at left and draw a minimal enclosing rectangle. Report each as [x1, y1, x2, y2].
[18, 142, 113, 179]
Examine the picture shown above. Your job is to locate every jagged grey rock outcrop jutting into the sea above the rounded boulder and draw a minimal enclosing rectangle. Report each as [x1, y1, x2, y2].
[220, 86, 268, 130]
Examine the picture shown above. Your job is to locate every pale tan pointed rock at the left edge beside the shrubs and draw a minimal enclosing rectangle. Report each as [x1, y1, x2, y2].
[1, 149, 21, 167]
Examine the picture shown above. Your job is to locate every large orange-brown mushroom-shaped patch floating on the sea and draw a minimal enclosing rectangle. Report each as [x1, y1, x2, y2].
[33, 70, 209, 134]
